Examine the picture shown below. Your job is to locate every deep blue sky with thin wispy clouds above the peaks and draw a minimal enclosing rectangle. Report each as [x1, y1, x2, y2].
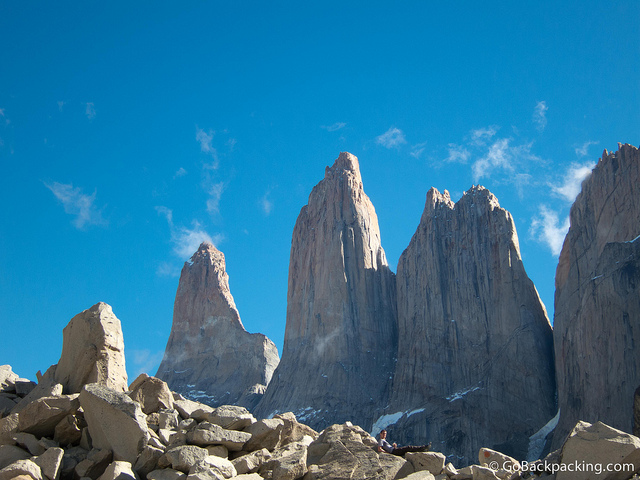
[0, 0, 640, 380]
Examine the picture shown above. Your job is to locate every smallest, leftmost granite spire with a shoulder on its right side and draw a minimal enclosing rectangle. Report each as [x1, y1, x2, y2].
[157, 243, 278, 408]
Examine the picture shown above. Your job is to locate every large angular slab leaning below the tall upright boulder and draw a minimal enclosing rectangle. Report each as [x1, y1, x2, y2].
[80, 383, 149, 464]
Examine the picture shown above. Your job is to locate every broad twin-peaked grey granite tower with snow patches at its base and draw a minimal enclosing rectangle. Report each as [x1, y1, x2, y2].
[388, 187, 556, 463]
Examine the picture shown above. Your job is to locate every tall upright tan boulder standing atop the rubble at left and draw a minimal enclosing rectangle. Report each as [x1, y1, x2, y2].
[55, 302, 128, 393]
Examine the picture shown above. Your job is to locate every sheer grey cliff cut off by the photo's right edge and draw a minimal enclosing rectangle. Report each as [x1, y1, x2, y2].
[554, 145, 640, 445]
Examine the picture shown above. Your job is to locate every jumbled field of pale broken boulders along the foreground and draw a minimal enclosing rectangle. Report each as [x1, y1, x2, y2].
[0, 304, 640, 480]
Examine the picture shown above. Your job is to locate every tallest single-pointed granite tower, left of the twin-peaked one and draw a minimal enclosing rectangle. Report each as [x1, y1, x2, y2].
[257, 153, 397, 428]
